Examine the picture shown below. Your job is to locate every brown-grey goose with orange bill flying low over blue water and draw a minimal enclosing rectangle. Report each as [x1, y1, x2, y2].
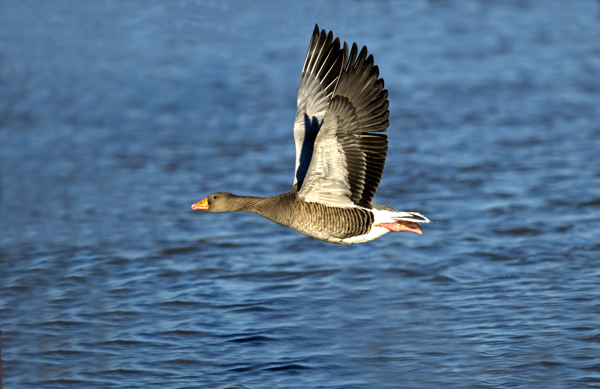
[192, 25, 429, 244]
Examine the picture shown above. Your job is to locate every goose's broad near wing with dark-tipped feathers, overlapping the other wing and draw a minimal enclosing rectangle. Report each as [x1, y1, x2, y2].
[298, 42, 389, 209]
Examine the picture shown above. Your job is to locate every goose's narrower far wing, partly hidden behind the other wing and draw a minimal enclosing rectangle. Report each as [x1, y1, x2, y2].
[294, 25, 345, 189]
